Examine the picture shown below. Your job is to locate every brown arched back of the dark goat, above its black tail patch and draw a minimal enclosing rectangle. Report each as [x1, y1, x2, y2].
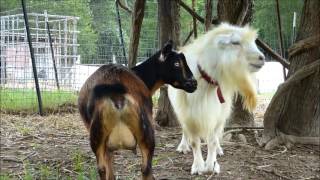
[78, 64, 152, 129]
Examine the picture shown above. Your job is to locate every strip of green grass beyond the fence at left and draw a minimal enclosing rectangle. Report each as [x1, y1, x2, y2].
[0, 88, 77, 112]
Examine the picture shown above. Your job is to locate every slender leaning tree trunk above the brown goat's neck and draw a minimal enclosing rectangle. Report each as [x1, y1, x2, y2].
[128, 0, 146, 68]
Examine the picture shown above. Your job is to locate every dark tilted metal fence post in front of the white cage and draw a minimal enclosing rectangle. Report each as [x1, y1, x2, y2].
[21, 0, 43, 116]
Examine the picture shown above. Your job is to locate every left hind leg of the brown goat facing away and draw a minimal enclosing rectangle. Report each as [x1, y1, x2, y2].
[90, 116, 115, 180]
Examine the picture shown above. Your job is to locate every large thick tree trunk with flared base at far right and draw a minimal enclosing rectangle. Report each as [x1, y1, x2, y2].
[262, 0, 320, 149]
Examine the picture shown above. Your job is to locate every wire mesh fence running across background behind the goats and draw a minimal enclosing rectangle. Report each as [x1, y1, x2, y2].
[0, 0, 300, 113]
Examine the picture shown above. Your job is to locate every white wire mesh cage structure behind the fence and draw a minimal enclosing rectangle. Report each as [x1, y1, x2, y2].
[0, 13, 80, 90]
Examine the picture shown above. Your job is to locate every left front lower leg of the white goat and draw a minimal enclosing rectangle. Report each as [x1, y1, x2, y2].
[189, 136, 205, 175]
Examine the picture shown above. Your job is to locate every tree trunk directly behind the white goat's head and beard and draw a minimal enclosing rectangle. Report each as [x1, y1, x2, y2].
[217, 0, 254, 126]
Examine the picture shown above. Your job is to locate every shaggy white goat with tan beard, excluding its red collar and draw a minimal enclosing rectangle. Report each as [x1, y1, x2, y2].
[169, 24, 264, 174]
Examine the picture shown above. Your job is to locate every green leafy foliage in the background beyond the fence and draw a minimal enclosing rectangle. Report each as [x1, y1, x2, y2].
[0, 0, 303, 64]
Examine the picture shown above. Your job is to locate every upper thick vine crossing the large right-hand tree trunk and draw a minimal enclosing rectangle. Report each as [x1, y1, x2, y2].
[288, 35, 320, 57]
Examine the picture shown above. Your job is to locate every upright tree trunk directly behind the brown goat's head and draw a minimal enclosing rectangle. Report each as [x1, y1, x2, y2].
[155, 0, 180, 126]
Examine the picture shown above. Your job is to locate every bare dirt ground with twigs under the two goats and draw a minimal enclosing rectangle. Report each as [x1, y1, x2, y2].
[0, 96, 320, 179]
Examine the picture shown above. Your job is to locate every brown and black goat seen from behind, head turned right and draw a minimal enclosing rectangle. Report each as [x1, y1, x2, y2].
[79, 42, 197, 179]
